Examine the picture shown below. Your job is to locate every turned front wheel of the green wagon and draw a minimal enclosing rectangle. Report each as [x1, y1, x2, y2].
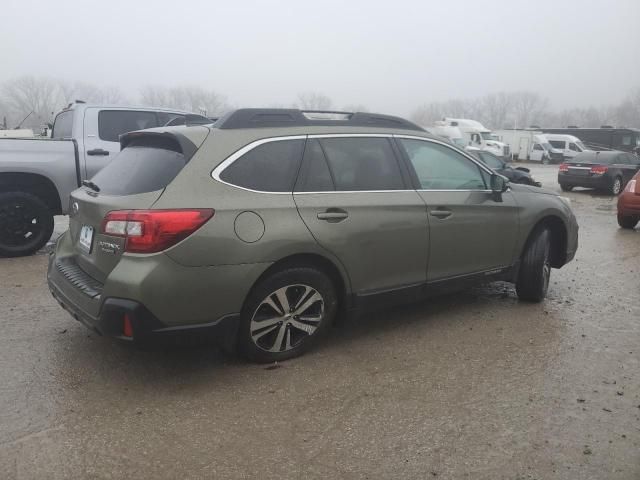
[516, 228, 551, 302]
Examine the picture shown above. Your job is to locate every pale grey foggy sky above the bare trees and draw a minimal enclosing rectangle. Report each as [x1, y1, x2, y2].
[0, 0, 640, 115]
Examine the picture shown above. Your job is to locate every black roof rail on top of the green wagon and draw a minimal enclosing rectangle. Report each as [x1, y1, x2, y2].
[214, 108, 424, 131]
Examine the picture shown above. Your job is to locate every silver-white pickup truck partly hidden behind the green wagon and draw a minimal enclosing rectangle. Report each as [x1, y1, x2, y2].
[0, 102, 211, 257]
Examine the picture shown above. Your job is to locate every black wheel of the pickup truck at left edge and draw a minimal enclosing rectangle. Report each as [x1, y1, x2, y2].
[0, 192, 53, 257]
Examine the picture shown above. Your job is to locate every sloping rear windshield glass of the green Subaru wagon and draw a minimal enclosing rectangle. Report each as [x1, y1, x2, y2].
[91, 137, 186, 195]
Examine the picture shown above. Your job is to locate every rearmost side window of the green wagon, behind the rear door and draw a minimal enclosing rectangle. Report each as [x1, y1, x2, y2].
[220, 140, 304, 192]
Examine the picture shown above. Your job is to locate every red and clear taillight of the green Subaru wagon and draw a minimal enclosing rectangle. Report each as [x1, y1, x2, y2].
[101, 208, 215, 253]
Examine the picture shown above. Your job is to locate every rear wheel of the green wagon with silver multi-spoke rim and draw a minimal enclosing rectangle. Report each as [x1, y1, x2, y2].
[238, 267, 338, 363]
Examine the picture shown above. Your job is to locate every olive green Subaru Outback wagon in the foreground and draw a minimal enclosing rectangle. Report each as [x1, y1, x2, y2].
[48, 109, 578, 361]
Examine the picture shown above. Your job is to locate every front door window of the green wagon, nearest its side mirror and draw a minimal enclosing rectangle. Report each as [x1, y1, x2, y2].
[400, 139, 487, 190]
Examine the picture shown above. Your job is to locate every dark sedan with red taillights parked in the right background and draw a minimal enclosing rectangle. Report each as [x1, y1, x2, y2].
[558, 150, 640, 195]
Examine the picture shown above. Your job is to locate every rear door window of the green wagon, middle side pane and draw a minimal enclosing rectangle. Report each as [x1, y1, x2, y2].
[320, 137, 404, 191]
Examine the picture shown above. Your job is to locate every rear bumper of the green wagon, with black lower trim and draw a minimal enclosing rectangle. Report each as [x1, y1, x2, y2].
[47, 233, 271, 348]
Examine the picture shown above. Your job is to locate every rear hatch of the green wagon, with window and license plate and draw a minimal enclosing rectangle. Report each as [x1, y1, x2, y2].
[69, 127, 204, 283]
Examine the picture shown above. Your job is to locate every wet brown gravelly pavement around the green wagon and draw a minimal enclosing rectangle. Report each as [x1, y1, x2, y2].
[0, 166, 640, 479]
